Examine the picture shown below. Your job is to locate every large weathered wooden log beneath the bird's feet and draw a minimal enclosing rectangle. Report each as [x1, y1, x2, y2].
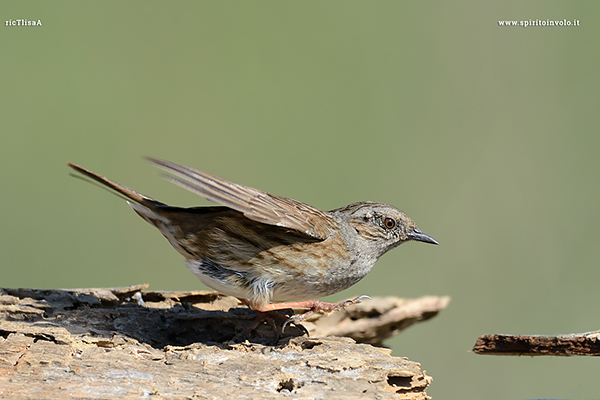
[0, 285, 449, 399]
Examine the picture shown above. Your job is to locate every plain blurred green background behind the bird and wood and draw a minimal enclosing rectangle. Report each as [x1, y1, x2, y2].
[0, 0, 600, 399]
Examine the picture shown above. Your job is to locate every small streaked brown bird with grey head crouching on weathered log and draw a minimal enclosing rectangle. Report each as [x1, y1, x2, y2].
[68, 157, 438, 329]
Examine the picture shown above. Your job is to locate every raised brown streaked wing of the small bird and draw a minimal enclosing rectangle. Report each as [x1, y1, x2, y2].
[148, 158, 337, 239]
